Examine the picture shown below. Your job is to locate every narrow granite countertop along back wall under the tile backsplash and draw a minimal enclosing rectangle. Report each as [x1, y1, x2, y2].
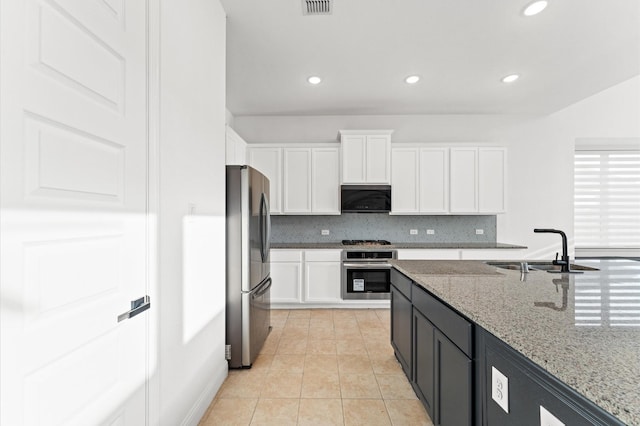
[271, 241, 527, 250]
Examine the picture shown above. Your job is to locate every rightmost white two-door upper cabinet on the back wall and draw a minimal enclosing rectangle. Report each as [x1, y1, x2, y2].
[449, 147, 507, 214]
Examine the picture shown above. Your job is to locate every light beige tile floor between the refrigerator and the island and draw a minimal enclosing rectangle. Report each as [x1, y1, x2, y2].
[200, 309, 433, 426]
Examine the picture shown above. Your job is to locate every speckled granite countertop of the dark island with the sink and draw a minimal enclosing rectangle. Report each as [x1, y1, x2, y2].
[393, 259, 640, 424]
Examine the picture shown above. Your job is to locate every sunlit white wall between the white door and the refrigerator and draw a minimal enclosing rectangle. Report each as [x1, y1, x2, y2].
[158, 0, 227, 425]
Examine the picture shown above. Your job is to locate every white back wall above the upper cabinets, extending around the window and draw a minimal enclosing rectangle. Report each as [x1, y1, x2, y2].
[234, 77, 640, 258]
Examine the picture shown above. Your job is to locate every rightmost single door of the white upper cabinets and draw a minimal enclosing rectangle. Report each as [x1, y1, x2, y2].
[478, 148, 507, 213]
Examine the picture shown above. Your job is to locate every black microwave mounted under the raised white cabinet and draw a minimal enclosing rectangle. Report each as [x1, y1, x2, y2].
[341, 185, 391, 213]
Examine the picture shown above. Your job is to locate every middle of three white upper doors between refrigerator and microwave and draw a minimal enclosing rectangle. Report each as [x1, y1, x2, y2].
[282, 148, 311, 214]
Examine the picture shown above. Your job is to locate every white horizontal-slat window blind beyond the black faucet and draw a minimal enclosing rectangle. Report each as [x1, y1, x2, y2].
[574, 150, 640, 249]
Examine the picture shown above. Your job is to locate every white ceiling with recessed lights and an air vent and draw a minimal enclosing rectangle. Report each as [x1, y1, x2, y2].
[221, 0, 640, 116]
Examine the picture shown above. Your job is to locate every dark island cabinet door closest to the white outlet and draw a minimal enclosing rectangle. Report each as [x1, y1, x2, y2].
[434, 329, 473, 426]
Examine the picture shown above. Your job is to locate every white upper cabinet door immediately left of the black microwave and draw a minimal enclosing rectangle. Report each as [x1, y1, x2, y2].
[311, 148, 340, 214]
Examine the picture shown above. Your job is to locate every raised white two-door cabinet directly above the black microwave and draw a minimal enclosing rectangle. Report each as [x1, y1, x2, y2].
[340, 130, 392, 184]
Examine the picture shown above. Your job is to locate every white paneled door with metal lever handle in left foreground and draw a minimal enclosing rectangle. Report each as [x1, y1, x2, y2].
[0, 0, 151, 425]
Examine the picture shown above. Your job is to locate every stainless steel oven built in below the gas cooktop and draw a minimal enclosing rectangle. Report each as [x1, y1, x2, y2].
[342, 249, 397, 300]
